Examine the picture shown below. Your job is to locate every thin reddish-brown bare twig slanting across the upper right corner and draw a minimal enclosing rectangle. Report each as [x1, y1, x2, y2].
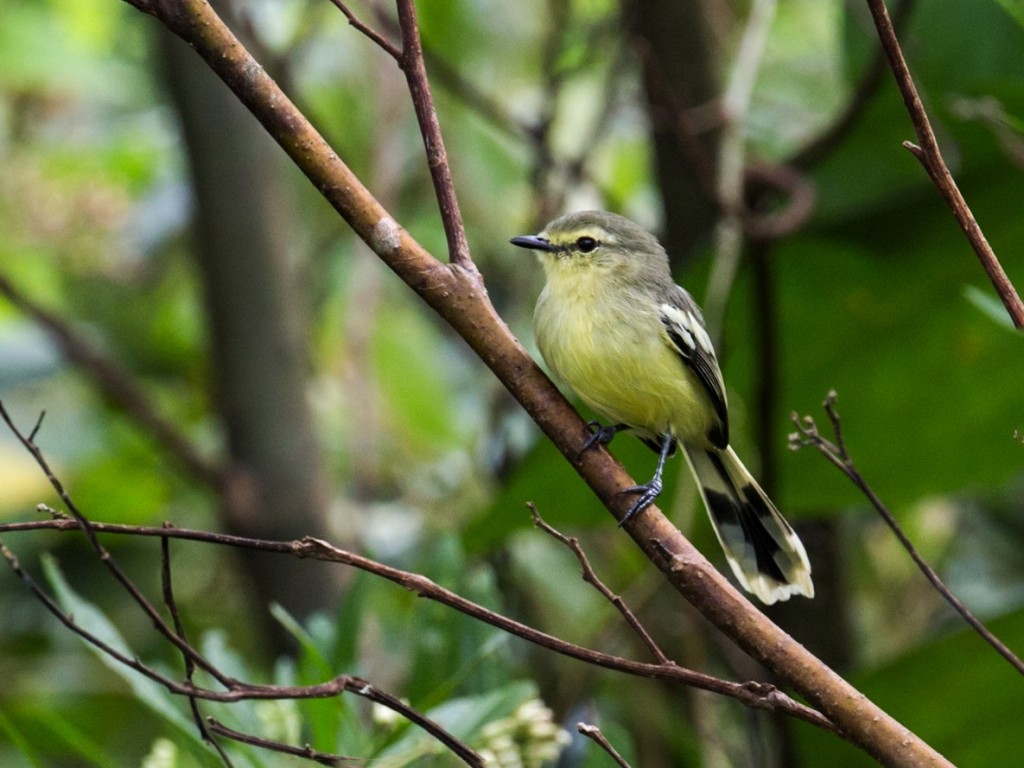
[867, 0, 1024, 329]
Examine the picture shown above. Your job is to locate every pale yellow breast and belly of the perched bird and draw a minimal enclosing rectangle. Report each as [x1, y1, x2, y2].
[534, 269, 716, 444]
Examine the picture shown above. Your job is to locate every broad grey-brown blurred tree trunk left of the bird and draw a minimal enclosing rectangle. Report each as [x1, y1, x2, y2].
[158, 9, 337, 650]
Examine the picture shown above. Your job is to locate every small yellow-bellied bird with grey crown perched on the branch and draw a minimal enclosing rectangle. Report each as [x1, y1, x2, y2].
[510, 211, 814, 604]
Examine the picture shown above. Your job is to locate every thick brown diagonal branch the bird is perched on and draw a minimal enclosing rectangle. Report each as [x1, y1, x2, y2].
[105, 0, 948, 766]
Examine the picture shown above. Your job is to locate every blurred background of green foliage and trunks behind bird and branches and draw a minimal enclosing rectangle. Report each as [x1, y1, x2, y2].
[0, 0, 1024, 767]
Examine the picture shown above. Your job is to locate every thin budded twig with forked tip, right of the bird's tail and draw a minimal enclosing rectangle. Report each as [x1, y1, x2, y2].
[790, 390, 1024, 675]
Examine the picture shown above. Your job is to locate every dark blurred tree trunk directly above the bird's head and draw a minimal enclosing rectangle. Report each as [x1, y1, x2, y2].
[625, 0, 719, 266]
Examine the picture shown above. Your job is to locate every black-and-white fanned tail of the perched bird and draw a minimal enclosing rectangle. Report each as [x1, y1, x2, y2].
[686, 445, 814, 605]
